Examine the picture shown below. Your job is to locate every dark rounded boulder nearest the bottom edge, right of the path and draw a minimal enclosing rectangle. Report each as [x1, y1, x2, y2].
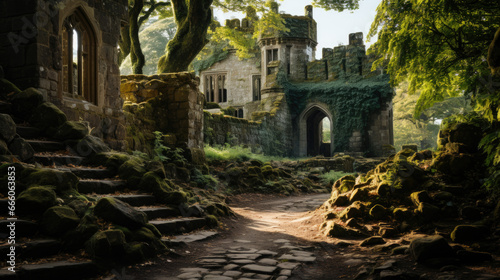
[409, 235, 455, 263]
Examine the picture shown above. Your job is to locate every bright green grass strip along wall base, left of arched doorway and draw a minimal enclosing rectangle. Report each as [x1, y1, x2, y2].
[205, 145, 294, 162]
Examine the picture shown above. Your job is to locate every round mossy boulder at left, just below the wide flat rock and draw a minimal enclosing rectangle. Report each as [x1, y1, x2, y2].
[16, 186, 57, 216]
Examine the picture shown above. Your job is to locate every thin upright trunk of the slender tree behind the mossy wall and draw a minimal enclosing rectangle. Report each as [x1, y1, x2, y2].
[129, 0, 146, 74]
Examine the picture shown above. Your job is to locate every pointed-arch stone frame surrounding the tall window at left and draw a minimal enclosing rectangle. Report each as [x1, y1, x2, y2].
[58, 4, 100, 109]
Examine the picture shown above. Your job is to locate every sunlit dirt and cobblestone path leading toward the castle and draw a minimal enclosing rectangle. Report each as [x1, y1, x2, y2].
[115, 194, 498, 280]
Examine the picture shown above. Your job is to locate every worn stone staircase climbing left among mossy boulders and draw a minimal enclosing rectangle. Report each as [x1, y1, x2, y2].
[0, 111, 216, 280]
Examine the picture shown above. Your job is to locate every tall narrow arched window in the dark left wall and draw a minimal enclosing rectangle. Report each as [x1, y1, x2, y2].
[62, 9, 97, 104]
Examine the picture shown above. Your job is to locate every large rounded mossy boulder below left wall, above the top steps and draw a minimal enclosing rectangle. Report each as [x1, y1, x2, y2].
[10, 88, 43, 119]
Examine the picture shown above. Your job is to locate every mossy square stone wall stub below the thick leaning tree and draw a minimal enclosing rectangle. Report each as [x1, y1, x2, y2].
[121, 72, 204, 154]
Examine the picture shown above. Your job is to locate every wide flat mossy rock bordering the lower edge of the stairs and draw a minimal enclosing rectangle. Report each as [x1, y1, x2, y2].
[26, 168, 79, 194]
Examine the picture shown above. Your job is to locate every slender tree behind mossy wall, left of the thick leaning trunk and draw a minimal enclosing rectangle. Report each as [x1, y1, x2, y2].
[118, 0, 170, 74]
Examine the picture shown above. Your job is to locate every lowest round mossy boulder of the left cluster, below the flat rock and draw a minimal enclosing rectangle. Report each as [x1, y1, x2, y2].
[40, 206, 80, 236]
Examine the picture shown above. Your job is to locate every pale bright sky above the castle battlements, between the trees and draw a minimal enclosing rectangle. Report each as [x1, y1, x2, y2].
[214, 0, 380, 59]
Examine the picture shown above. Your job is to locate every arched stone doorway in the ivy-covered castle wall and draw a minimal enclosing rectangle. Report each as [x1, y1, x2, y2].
[299, 103, 334, 157]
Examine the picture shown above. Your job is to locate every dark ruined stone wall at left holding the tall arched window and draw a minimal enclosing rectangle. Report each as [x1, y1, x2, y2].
[0, 0, 127, 149]
